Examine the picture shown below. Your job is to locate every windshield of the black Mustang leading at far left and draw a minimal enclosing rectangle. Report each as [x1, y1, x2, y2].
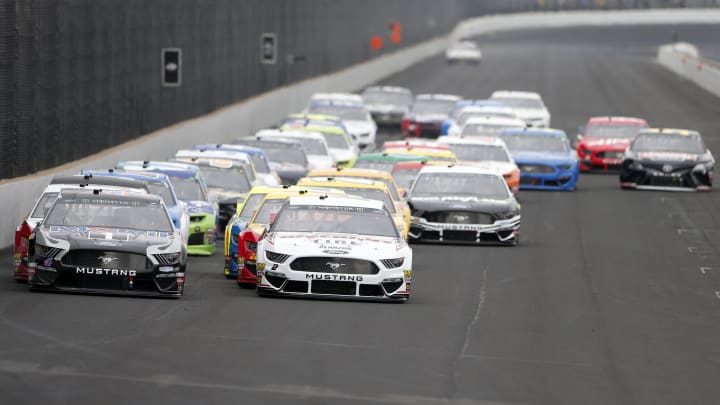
[45, 198, 173, 232]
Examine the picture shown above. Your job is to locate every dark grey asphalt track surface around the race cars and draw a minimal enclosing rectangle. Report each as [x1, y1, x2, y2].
[0, 26, 720, 404]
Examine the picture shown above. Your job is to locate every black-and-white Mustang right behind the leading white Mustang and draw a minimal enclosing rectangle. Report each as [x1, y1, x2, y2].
[408, 165, 521, 245]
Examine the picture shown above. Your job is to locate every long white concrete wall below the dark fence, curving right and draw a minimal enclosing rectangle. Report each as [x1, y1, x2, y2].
[0, 9, 720, 247]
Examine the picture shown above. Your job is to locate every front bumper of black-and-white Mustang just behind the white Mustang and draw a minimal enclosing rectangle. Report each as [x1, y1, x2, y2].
[409, 215, 521, 244]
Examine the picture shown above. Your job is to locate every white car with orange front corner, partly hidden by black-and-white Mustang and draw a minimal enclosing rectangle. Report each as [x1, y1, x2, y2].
[440, 136, 520, 194]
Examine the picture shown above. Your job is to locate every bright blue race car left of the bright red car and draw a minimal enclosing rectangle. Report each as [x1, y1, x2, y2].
[500, 128, 579, 191]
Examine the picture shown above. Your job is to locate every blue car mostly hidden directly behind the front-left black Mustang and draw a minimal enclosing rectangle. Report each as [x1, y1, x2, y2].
[80, 169, 190, 244]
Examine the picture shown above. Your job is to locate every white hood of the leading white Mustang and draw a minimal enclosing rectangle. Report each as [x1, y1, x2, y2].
[263, 232, 409, 259]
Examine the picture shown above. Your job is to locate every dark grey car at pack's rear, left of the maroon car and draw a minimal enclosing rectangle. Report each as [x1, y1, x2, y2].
[362, 86, 413, 125]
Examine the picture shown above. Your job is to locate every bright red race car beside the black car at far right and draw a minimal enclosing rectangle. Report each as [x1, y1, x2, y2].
[576, 117, 648, 172]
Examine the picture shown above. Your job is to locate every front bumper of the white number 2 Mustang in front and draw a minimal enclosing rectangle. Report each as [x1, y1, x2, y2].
[257, 262, 412, 302]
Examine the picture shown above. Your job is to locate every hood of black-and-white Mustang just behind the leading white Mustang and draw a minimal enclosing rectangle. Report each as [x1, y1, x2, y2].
[408, 195, 517, 216]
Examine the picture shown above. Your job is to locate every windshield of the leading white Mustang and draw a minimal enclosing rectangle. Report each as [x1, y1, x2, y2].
[270, 205, 399, 238]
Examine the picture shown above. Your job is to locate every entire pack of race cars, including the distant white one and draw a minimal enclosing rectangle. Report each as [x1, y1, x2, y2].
[13, 82, 714, 302]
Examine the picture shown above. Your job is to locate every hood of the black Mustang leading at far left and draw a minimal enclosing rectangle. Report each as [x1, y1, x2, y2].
[35, 226, 182, 254]
